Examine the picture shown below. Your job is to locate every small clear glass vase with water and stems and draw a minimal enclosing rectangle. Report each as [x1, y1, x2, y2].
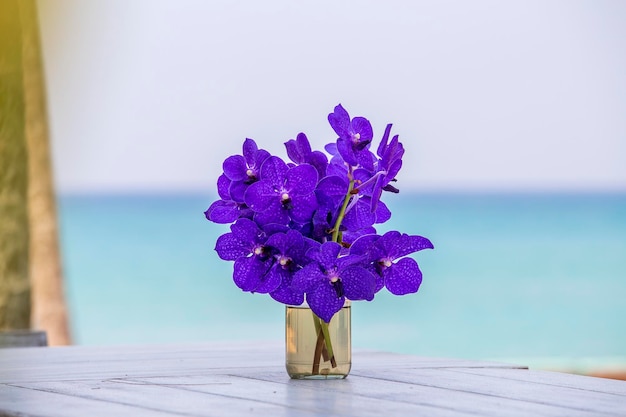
[285, 300, 352, 379]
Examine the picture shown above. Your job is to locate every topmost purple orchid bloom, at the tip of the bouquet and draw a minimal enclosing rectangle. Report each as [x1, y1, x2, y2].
[328, 104, 374, 170]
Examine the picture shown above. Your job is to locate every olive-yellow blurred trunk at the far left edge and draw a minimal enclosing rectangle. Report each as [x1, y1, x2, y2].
[0, 0, 30, 331]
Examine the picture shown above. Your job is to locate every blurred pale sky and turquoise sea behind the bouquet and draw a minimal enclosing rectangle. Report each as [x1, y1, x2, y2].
[30, 0, 626, 373]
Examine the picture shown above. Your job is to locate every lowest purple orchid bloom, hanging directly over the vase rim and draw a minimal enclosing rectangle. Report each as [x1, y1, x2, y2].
[291, 242, 376, 323]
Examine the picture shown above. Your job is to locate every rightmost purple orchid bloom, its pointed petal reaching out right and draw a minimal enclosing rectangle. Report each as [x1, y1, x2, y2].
[350, 230, 434, 295]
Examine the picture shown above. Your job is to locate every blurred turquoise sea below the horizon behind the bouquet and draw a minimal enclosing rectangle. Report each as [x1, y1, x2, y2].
[58, 192, 626, 369]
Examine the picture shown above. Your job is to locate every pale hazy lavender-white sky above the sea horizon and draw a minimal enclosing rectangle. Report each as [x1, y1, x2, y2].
[38, 0, 626, 193]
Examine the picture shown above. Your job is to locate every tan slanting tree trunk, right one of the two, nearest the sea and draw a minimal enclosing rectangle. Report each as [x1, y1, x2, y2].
[19, 0, 71, 346]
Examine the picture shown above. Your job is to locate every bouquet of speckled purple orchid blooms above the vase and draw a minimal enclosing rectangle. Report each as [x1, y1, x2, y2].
[205, 105, 433, 323]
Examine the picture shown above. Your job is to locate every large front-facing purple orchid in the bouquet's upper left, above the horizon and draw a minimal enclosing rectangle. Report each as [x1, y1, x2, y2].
[244, 156, 317, 224]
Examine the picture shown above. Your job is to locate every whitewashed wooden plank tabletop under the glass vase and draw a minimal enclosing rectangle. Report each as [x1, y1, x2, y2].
[0, 342, 626, 417]
